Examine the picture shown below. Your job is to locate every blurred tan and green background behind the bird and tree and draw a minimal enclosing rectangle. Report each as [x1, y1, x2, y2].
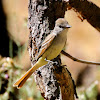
[0, 0, 100, 100]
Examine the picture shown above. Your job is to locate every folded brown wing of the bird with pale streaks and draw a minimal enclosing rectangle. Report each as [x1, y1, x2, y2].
[38, 33, 56, 58]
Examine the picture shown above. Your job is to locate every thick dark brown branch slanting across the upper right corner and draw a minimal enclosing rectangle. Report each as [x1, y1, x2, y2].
[64, 0, 100, 32]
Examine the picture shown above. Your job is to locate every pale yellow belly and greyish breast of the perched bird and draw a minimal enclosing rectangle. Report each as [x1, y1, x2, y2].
[42, 32, 67, 60]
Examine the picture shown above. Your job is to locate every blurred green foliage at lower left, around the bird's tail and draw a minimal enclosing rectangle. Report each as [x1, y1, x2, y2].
[0, 56, 43, 100]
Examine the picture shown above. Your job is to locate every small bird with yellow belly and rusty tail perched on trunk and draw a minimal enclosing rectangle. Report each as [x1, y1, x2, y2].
[13, 18, 71, 89]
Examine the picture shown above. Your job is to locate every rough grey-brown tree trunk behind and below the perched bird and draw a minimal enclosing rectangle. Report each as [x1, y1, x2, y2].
[28, 0, 74, 100]
